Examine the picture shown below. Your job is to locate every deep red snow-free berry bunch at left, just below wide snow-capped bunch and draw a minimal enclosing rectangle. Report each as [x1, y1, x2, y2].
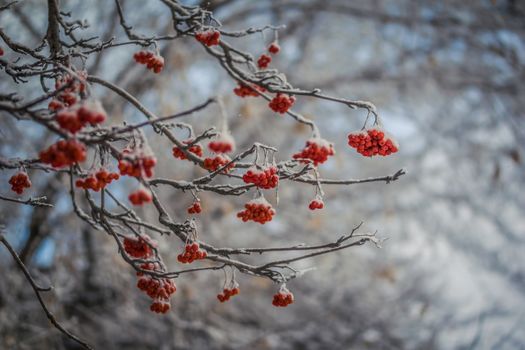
[39, 139, 86, 168]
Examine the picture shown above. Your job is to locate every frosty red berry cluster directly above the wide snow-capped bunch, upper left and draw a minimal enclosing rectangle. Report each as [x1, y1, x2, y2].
[48, 71, 87, 111]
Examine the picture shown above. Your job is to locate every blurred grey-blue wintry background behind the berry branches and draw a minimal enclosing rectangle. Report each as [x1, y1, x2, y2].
[0, 0, 525, 349]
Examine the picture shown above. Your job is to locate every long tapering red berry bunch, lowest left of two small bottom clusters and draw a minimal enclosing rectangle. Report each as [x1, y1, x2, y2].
[137, 263, 177, 314]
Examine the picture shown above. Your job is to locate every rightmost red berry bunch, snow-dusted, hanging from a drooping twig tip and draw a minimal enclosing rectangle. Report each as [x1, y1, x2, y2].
[348, 128, 399, 157]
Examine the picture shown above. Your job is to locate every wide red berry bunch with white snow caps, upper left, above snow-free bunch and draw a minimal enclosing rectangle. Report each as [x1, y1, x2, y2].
[55, 101, 106, 134]
